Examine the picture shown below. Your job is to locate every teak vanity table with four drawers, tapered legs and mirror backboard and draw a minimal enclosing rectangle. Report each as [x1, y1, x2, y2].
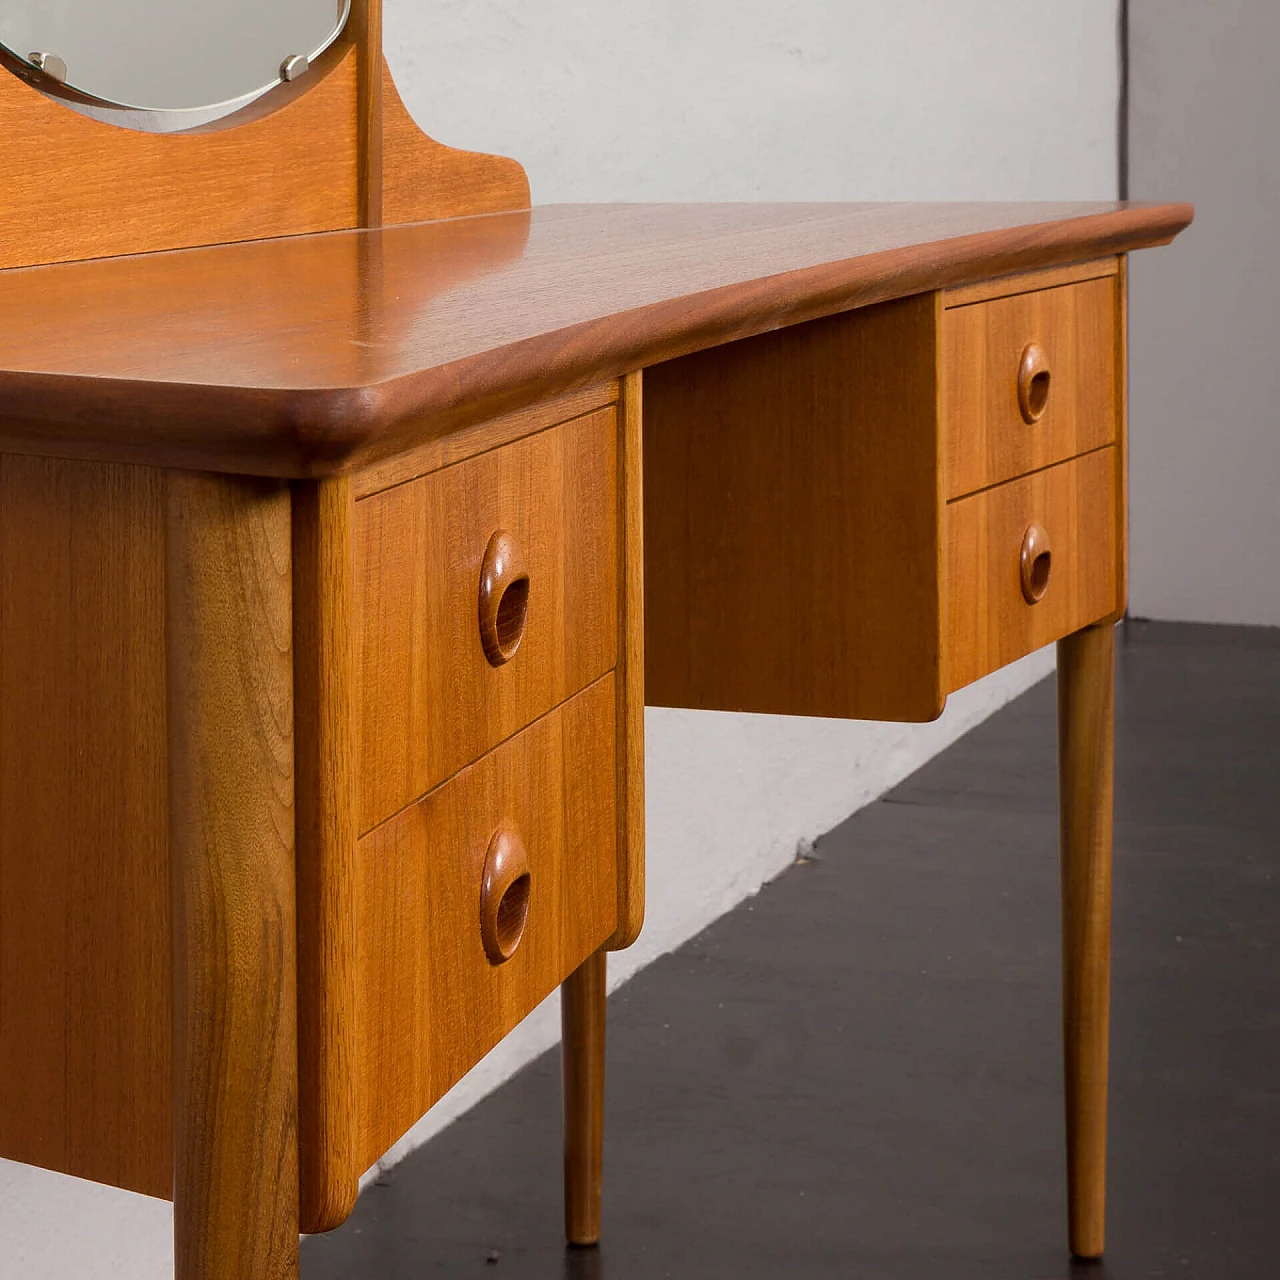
[0, 0, 1190, 1280]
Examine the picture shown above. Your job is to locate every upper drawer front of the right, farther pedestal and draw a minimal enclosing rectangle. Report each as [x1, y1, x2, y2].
[942, 275, 1119, 498]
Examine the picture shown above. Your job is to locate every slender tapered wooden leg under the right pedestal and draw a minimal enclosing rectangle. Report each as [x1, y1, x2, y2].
[1057, 625, 1115, 1258]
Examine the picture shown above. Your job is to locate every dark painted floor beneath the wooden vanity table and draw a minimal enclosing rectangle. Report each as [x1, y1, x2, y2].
[303, 623, 1280, 1280]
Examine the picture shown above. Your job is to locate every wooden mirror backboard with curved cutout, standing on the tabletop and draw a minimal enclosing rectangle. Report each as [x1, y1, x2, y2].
[0, 0, 530, 270]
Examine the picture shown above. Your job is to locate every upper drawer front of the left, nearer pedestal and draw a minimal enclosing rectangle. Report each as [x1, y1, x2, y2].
[355, 407, 618, 832]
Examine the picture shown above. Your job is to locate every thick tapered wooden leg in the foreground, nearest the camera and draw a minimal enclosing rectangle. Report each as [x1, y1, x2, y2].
[165, 472, 298, 1280]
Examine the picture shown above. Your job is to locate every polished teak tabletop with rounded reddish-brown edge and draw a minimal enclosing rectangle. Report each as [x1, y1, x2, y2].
[0, 204, 1192, 477]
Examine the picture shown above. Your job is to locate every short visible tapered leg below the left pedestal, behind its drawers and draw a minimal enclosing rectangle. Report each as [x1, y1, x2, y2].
[561, 951, 605, 1244]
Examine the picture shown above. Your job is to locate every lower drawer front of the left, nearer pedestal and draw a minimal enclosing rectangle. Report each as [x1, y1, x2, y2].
[356, 675, 617, 1169]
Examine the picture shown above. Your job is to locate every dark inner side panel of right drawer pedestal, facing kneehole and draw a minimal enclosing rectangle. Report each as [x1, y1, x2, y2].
[644, 293, 947, 721]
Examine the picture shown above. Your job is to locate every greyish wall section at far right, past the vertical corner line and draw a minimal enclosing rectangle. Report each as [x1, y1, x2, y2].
[1129, 0, 1280, 626]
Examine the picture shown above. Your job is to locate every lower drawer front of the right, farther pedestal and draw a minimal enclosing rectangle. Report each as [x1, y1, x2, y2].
[947, 447, 1120, 690]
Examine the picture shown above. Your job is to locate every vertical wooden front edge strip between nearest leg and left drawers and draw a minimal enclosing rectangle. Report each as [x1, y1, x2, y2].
[293, 477, 364, 1233]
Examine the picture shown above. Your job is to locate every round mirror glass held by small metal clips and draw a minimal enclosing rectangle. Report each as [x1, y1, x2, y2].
[0, 0, 349, 127]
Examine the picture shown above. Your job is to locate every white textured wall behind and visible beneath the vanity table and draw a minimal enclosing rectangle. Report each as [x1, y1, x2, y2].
[0, 0, 1116, 1280]
